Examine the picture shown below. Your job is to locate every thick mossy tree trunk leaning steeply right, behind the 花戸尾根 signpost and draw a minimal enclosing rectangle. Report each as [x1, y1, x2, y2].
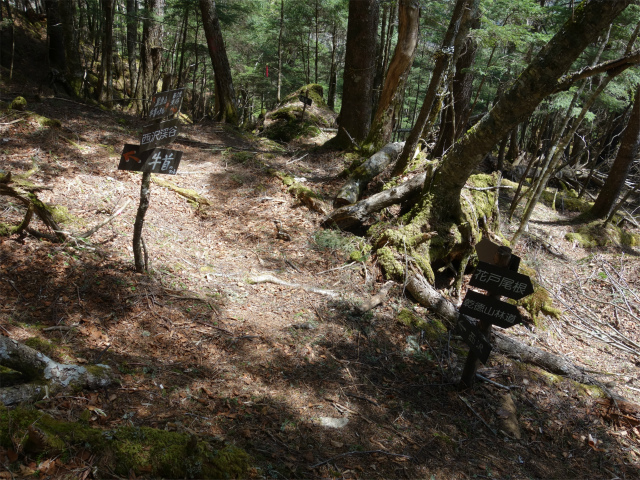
[383, 0, 632, 282]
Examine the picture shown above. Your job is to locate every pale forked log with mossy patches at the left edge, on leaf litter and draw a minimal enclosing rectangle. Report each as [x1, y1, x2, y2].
[0, 335, 112, 405]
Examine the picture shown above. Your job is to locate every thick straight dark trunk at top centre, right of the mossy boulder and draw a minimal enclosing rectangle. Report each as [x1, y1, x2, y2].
[329, 0, 380, 148]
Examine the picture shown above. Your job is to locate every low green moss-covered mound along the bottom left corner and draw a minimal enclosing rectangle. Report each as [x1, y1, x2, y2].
[0, 406, 249, 478]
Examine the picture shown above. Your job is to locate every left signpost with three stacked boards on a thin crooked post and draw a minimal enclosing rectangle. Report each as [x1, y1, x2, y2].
[118, 88, 184, 273]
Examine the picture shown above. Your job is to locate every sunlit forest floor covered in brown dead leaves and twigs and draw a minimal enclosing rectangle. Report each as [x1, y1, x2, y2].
[0, 84, 640, 479]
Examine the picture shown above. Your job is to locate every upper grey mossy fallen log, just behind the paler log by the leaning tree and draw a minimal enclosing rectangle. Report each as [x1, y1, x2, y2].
[333, 142, 404, 207]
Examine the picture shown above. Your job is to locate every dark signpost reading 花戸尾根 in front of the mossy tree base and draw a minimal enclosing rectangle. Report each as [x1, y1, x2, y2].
[458, 239, 533, 387]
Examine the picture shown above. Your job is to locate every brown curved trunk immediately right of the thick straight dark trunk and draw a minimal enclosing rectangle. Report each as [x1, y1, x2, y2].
[366, 0, 420, 152]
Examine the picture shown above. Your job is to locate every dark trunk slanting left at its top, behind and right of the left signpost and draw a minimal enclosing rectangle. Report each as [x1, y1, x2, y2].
[199, 0, 238, 125]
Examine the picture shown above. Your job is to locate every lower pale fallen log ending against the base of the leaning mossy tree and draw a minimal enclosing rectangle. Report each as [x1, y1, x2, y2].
[322, 173, 426, 230]
